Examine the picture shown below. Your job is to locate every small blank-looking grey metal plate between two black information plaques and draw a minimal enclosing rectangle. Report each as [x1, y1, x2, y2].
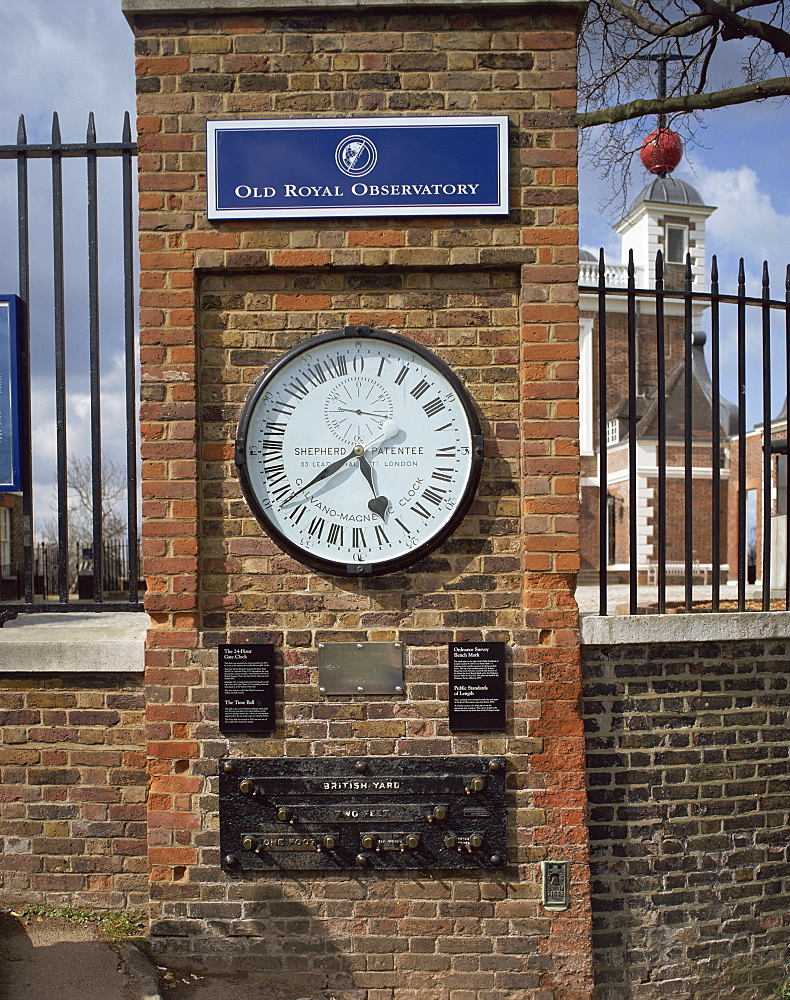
[318, 642, 403, 695]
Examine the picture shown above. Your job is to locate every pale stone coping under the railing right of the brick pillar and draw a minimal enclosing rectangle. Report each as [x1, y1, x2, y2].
[581, 611, 790, 646]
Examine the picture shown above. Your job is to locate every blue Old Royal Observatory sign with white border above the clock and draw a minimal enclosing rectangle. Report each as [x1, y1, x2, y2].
[206, 116, 509, 219]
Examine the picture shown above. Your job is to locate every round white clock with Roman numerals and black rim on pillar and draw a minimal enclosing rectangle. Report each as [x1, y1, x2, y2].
[235, 326, 483, 576]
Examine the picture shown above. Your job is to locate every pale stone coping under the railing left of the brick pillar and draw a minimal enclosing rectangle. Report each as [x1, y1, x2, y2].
[0, 612, 150, 674]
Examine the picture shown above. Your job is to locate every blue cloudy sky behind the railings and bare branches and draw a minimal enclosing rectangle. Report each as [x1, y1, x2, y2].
[0, 0, 790, 528]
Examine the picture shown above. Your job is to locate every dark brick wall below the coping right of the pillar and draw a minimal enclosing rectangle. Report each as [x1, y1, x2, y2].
[583, 639, 790, 1000]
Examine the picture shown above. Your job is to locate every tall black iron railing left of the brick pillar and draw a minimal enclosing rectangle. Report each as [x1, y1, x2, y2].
[0, 114, 142, 624]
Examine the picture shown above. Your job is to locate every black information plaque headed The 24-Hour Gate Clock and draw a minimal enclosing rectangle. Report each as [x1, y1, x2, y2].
[219, 642, 274, 733]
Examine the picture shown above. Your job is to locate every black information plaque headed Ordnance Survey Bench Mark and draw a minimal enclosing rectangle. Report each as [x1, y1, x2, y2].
[450, 642, 505, 731]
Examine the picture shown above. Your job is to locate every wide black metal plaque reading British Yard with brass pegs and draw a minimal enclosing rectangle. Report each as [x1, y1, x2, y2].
[219, 757, 507, 875]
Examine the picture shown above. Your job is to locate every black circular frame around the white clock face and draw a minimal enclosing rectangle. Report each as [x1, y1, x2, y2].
[234, 326, 483, 576]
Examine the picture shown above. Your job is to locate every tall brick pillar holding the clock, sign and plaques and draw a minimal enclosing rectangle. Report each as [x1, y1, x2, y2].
[124, 0, 592, 1000]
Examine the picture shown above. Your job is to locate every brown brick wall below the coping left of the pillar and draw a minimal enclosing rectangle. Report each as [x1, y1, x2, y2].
[0, 674, 148, 909]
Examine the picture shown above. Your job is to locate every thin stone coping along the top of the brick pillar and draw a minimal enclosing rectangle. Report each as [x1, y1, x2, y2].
[121, 0, 586, 21]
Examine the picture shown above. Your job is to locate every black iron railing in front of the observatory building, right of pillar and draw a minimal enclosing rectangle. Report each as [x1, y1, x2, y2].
[580, 251, 790, 615]
